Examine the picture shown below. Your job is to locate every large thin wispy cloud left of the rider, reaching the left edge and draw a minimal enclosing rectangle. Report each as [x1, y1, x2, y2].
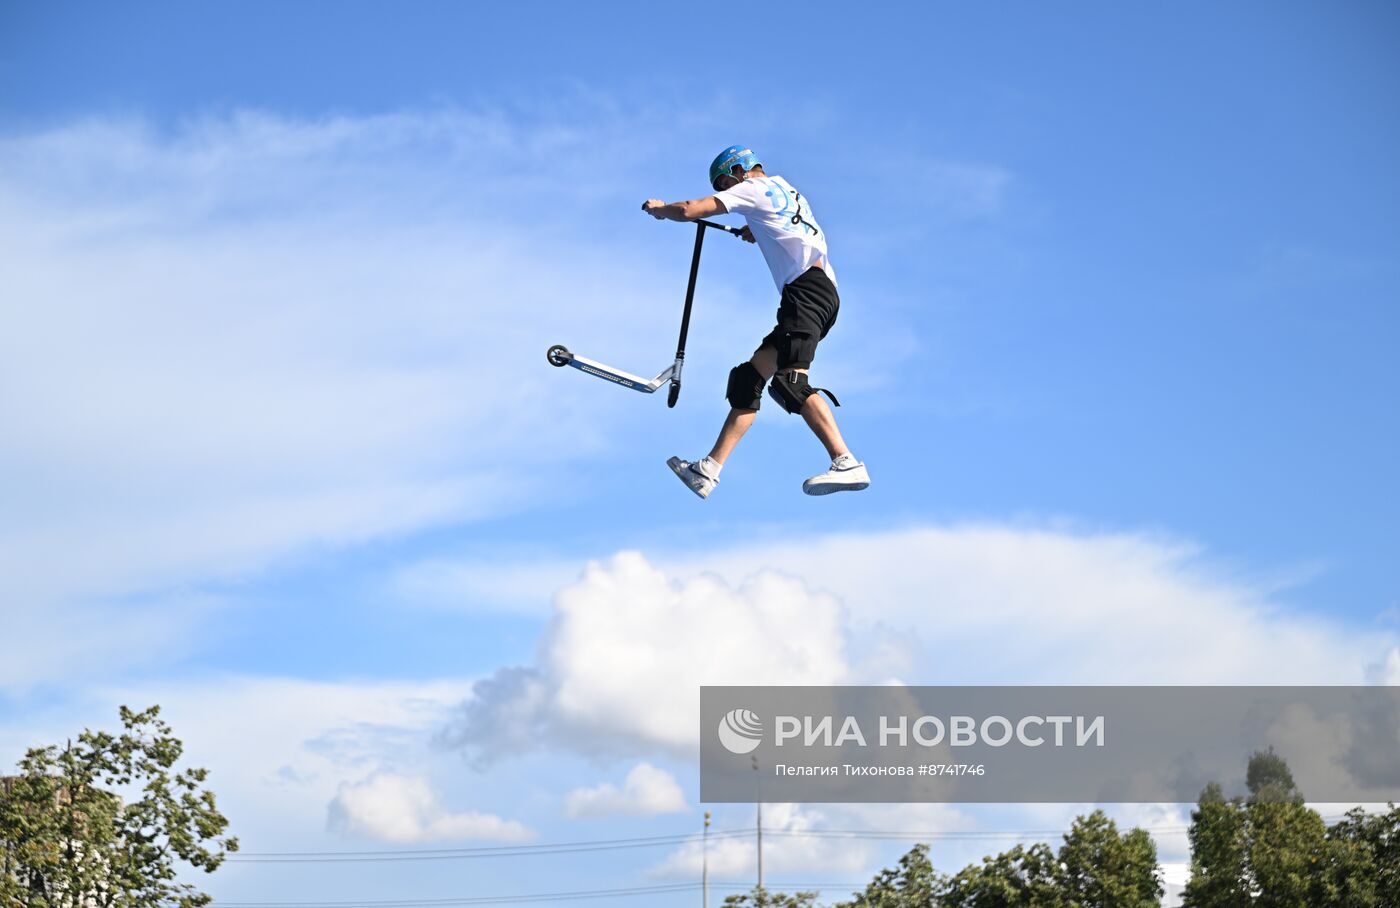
[0, 104, 716, 690]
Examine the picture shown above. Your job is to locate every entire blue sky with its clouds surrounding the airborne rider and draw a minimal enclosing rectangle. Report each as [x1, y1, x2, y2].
[0, 3, 1400, 904]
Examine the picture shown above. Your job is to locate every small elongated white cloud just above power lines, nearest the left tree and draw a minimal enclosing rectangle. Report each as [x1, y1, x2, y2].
[326, 772, 535, 844]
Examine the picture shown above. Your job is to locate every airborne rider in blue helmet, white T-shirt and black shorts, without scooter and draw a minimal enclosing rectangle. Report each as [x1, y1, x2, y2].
[641, 146, 871, 498]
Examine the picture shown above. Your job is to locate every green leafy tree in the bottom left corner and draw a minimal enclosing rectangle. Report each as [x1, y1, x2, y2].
[0, 707, 238, 908]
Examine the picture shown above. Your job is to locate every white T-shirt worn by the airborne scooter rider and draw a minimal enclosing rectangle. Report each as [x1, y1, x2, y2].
[714, 176, 836, 291]
